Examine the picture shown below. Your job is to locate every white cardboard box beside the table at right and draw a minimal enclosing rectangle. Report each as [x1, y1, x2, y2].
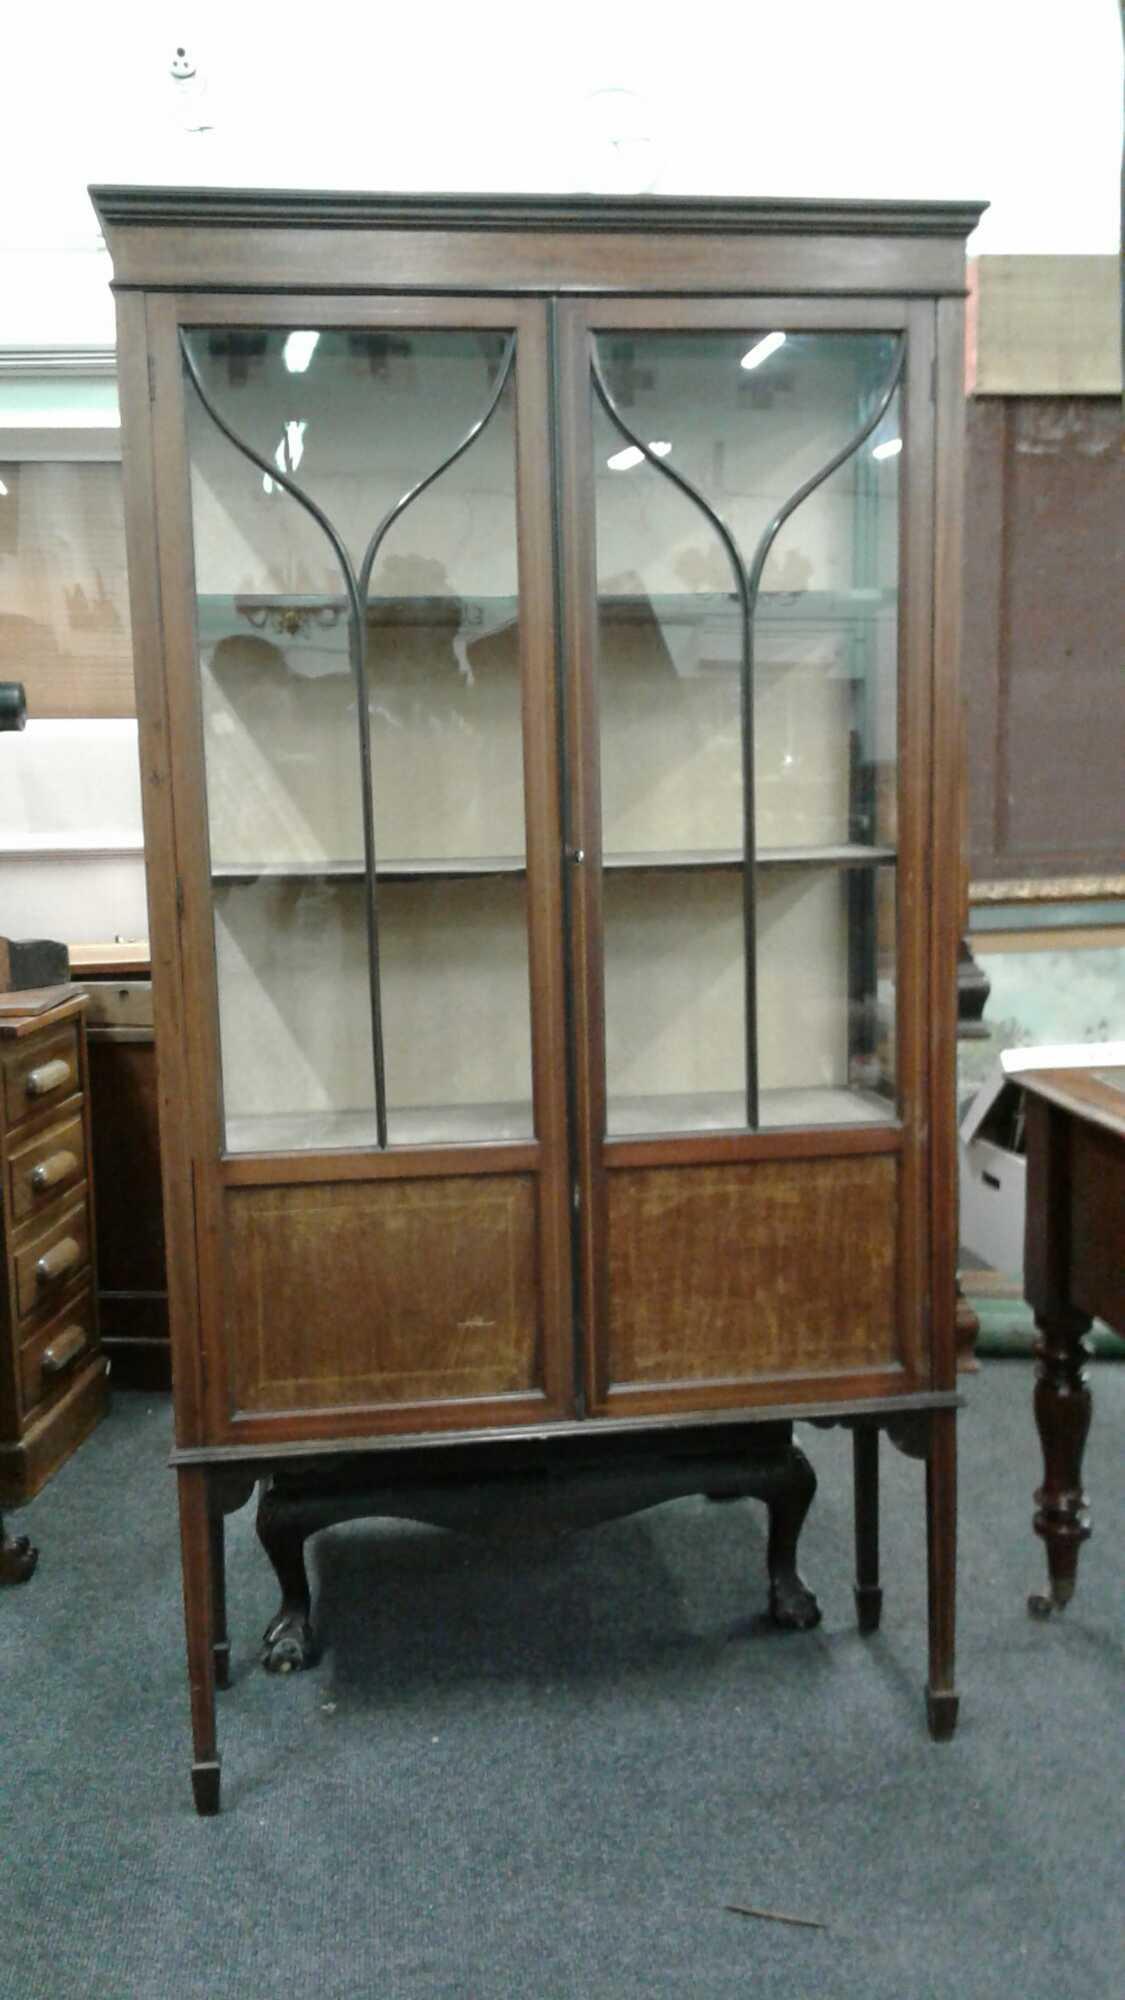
[959, 1042, 1125, 1278]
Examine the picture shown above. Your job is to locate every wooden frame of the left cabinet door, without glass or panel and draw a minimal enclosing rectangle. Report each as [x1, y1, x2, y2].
[133, 288, 573, 1446]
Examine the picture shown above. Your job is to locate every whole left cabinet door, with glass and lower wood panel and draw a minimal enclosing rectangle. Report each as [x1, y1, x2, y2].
[150, 296, 571, 1438]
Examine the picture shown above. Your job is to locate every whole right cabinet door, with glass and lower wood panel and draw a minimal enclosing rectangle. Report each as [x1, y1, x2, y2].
[565, 300, 933, 1410]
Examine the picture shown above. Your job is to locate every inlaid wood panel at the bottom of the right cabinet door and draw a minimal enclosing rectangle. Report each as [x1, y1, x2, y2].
[607, 1156, 899, 1384]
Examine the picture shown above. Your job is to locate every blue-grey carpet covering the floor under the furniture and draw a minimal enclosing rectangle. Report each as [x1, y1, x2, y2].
[0, 1360, 1125, 2000]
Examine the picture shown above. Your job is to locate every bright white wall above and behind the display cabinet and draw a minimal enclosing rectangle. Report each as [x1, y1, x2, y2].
[0, 0, 1121, 346]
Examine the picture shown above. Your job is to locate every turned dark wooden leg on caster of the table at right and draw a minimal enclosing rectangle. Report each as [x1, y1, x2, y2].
[1029, 1306, 1093, 1616]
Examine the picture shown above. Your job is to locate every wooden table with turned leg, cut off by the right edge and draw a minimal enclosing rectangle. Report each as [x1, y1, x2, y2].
[1021, 1066, 1125, 1616]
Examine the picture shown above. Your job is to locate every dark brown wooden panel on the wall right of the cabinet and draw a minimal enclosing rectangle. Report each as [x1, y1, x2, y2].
[963, 396, 1125, 882]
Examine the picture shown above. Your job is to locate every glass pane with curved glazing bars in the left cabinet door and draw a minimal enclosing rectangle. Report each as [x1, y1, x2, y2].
[186, 328, 530, 1150]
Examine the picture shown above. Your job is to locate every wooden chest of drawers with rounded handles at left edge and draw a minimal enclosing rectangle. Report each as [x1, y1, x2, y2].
[0, 988, 108, 1506]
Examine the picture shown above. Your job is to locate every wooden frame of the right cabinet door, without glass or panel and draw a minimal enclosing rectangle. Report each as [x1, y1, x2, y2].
[556, 292, 936, 1416]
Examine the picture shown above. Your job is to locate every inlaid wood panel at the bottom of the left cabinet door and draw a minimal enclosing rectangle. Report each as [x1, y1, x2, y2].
[226, 1174, 540, 1412]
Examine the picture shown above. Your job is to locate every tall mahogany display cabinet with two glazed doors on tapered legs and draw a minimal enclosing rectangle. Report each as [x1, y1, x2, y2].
[92, 188, 979, 1810]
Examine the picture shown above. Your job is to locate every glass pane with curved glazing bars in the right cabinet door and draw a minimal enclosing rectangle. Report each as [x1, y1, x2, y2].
[595, 328, 901, 1132]
